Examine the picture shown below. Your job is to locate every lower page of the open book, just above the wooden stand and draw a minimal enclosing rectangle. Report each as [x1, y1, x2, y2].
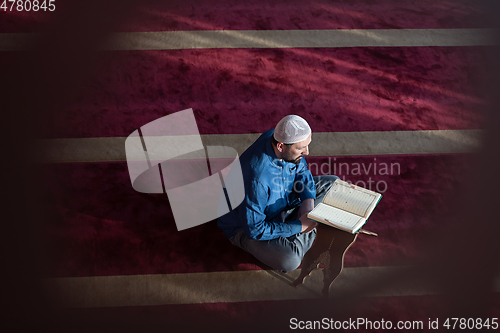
[307, 203, 365, 233]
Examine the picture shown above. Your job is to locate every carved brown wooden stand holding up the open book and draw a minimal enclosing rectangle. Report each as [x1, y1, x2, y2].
[292, 223, 377, 297]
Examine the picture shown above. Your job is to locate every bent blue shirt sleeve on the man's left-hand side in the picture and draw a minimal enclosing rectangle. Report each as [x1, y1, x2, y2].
[242, 181, 302, 240]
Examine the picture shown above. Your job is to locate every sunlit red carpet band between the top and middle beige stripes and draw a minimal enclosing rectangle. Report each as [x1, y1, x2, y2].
[0, 47, 488, 138]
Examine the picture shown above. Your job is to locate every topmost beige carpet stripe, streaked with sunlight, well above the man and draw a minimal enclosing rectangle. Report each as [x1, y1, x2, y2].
[0, 29, 496, 51]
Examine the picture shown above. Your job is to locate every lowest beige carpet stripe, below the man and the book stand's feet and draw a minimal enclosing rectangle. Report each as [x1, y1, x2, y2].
[44, 266, 500, 308]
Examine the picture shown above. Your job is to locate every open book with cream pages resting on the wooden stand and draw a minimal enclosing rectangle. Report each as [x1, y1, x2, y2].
[307, 179, 382, 234]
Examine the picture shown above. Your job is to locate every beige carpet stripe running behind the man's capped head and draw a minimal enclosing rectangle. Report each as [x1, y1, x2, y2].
[36, 129, 482, 163]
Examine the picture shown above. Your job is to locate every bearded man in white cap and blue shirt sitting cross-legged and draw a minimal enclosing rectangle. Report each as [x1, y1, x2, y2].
[217, 115, 338, 272]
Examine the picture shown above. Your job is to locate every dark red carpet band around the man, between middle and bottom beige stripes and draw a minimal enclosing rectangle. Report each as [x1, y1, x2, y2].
[42, 155, 469, 276]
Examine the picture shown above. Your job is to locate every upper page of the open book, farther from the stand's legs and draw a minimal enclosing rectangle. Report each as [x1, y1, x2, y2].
[323, 179, 381, 219]
